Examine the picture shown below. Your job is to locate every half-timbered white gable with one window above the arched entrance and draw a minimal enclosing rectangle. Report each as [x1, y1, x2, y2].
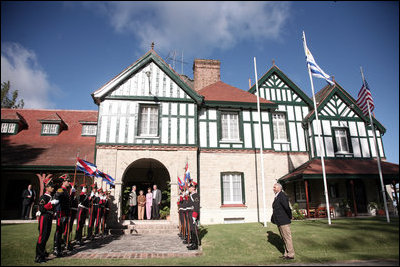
[93, 50, 202, 146]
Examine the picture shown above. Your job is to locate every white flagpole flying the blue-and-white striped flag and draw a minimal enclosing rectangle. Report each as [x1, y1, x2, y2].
[303, 31, 332, 224]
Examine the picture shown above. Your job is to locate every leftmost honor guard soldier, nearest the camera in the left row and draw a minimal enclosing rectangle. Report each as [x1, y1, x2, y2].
[35, 179, 59, 263]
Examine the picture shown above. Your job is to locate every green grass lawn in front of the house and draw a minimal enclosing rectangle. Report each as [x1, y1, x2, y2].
[1, 217, 399, 266]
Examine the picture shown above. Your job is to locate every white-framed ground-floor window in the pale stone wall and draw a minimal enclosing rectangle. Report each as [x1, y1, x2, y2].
[221, 173, 245, 204]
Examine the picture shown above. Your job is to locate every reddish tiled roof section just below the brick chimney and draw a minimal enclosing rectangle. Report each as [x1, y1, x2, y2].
[199, 81, 277, 108]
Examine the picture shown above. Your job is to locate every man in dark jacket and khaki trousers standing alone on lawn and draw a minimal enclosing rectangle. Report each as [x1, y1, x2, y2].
[271, 183, 294, 260]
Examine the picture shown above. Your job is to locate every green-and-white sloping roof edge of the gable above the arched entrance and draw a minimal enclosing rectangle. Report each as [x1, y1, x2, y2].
[92, 49, 203, 104]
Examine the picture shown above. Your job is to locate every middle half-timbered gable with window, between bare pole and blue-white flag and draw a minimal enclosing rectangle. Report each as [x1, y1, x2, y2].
[249, 65, 312, 152]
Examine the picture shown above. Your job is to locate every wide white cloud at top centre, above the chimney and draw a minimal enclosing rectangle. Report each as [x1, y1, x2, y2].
[84, 1, 290, 56]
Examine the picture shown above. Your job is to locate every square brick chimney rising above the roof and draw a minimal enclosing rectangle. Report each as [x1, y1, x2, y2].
[193, 59, 221, 91]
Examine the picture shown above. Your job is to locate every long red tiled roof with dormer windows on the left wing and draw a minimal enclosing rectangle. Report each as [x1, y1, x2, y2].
[1, 109, 98, 167]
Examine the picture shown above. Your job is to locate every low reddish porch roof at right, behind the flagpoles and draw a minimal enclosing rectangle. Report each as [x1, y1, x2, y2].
[278, 159, 399, 182]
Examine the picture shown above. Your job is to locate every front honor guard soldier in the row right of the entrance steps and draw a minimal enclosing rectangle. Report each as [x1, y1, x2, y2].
[187, 182, 200, 250]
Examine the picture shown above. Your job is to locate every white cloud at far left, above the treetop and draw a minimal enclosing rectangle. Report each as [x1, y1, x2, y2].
[1, 43, 55, 108]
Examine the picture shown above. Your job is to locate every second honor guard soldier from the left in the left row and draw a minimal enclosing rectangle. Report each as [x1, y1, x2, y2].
[54, 174, 71, 257]
